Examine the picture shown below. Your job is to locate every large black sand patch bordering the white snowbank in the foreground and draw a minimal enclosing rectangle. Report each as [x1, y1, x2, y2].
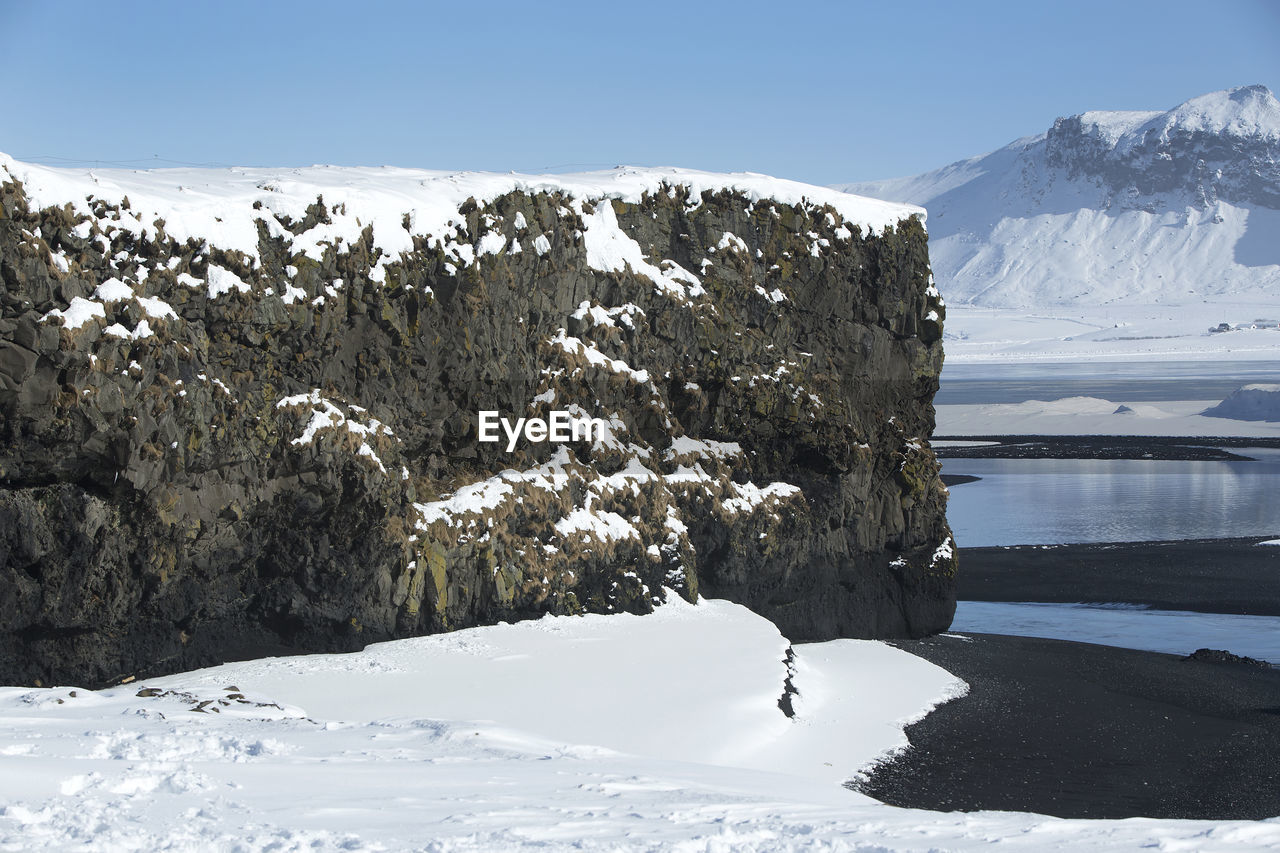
[858, 634, 1280, 820]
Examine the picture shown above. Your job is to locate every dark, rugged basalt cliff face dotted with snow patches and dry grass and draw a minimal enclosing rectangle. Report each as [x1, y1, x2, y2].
[0, 161, 956, 684]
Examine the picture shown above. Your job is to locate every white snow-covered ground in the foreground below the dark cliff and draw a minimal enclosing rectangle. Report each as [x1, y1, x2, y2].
[0, 597, 1280, 850]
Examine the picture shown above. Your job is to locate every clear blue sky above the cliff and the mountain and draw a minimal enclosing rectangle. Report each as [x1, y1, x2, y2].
[0, 0, 1280, 183]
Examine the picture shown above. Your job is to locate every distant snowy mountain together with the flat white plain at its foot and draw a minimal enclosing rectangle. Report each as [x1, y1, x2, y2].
[838, 86, 1280, 361]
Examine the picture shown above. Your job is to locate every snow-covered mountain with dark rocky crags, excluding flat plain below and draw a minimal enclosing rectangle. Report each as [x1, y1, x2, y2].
[838, 86, 1280, 307]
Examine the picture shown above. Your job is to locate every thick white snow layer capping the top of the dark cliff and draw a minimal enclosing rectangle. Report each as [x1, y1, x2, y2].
[0, 154, 924, 256]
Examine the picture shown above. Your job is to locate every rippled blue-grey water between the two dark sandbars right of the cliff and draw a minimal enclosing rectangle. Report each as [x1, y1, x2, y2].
[942, 450, 1280, 547]
